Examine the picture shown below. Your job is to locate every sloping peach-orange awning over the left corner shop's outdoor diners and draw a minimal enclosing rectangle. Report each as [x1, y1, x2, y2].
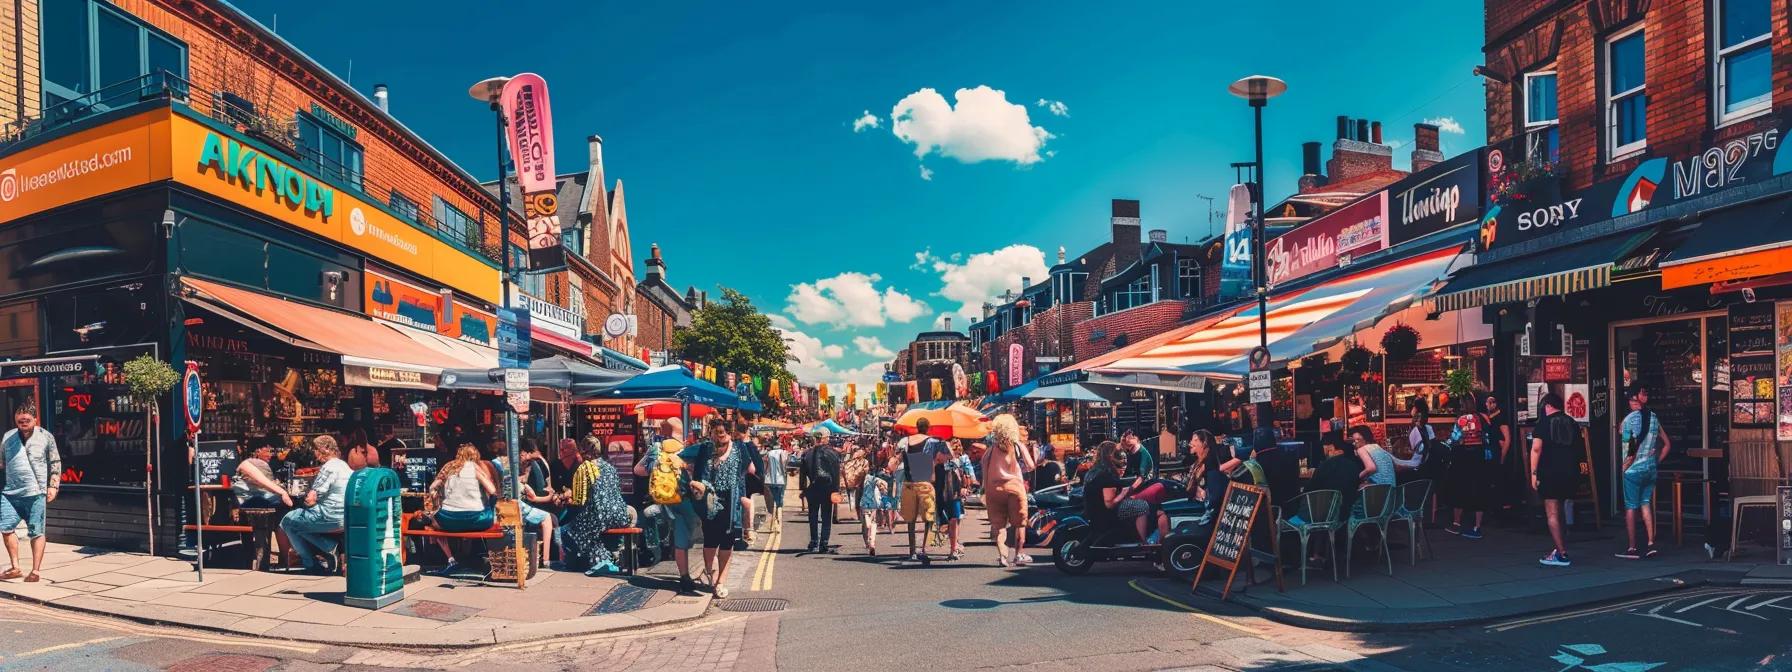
[181, 278, 468, 391]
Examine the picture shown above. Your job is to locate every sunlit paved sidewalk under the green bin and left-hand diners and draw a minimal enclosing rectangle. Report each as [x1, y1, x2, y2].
[0, 543, 710, 647]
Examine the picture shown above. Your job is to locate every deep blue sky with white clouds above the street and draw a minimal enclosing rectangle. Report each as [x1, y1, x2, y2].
[238, 0, 1486, 388]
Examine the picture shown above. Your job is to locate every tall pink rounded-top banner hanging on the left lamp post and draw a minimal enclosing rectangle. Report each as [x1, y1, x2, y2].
[502, 72, 566, 272]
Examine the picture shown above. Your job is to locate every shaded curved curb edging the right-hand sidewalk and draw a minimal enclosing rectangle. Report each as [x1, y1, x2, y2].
[1140, 570, 1745, 633]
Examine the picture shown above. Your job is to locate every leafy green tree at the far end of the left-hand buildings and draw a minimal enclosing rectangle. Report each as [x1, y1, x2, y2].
[672, 287, 790, 380]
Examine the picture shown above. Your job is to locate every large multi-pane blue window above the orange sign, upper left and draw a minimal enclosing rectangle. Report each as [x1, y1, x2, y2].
[39, 0, 186, 109]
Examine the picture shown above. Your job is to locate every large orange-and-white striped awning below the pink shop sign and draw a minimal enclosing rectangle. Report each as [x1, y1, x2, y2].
[1088, 246, 1462, 379]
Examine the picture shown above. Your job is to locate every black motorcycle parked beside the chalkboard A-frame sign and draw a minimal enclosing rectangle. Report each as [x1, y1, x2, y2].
[1029, 478, 1211, 577]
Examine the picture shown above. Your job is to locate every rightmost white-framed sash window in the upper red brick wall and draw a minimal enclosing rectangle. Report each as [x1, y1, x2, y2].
[1711, 0, 1774, 124]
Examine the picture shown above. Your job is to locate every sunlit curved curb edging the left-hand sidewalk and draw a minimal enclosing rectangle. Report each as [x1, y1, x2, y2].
[0, 593, 715, 649]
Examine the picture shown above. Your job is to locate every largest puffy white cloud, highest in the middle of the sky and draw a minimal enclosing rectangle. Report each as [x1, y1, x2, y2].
[891, 86, 1052, 165]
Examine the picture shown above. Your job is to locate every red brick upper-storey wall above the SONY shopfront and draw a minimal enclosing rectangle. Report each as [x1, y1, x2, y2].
[1484, 0, 1792, 188]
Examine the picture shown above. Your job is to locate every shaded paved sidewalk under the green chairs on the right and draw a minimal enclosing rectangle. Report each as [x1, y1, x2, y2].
[1149, 525, 1770, 633]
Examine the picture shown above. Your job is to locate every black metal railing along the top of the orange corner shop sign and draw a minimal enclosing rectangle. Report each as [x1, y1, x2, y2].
[0, 70, 504, 263]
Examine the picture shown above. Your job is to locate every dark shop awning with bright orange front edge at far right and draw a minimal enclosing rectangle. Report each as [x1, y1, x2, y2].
[1661, 199, 1792, 289]
